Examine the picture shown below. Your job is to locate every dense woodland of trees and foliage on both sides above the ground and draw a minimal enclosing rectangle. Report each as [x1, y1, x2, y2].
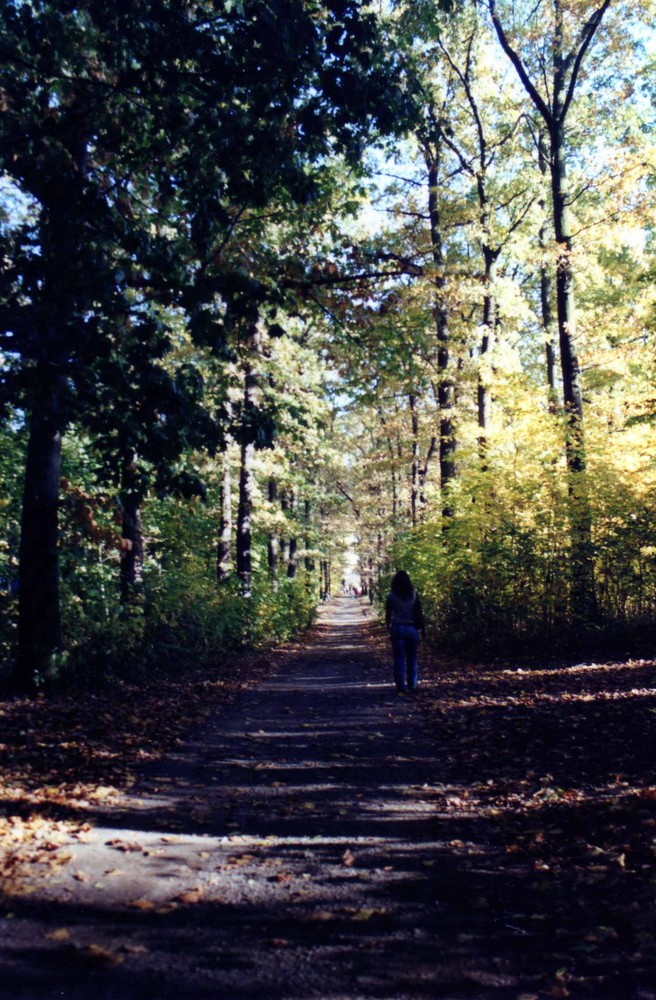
[0, 0, 656, 691]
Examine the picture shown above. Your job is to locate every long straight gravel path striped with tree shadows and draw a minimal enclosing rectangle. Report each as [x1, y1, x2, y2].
[0, 598, 508, 1000]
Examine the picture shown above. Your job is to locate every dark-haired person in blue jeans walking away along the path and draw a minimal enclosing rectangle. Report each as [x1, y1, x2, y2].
[385, 569, 426, 693]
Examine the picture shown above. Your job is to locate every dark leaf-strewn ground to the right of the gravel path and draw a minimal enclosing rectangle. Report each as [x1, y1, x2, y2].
[418, 660, 656, 1000]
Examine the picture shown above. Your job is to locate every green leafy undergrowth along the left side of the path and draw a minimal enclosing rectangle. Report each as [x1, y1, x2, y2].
[17, 486, 318, 687]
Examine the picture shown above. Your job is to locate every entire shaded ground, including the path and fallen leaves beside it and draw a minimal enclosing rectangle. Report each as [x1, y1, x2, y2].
[0, 599, 656, 1000]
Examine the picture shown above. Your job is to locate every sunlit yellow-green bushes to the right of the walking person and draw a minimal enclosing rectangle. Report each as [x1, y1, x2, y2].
[384, 424, 656, 653]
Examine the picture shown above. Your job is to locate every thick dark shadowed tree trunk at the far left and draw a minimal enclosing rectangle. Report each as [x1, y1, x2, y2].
[12, 361, 66, 694]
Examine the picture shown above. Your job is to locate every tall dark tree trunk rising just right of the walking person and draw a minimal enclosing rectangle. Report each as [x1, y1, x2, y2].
[426, 151, 456, 519]
